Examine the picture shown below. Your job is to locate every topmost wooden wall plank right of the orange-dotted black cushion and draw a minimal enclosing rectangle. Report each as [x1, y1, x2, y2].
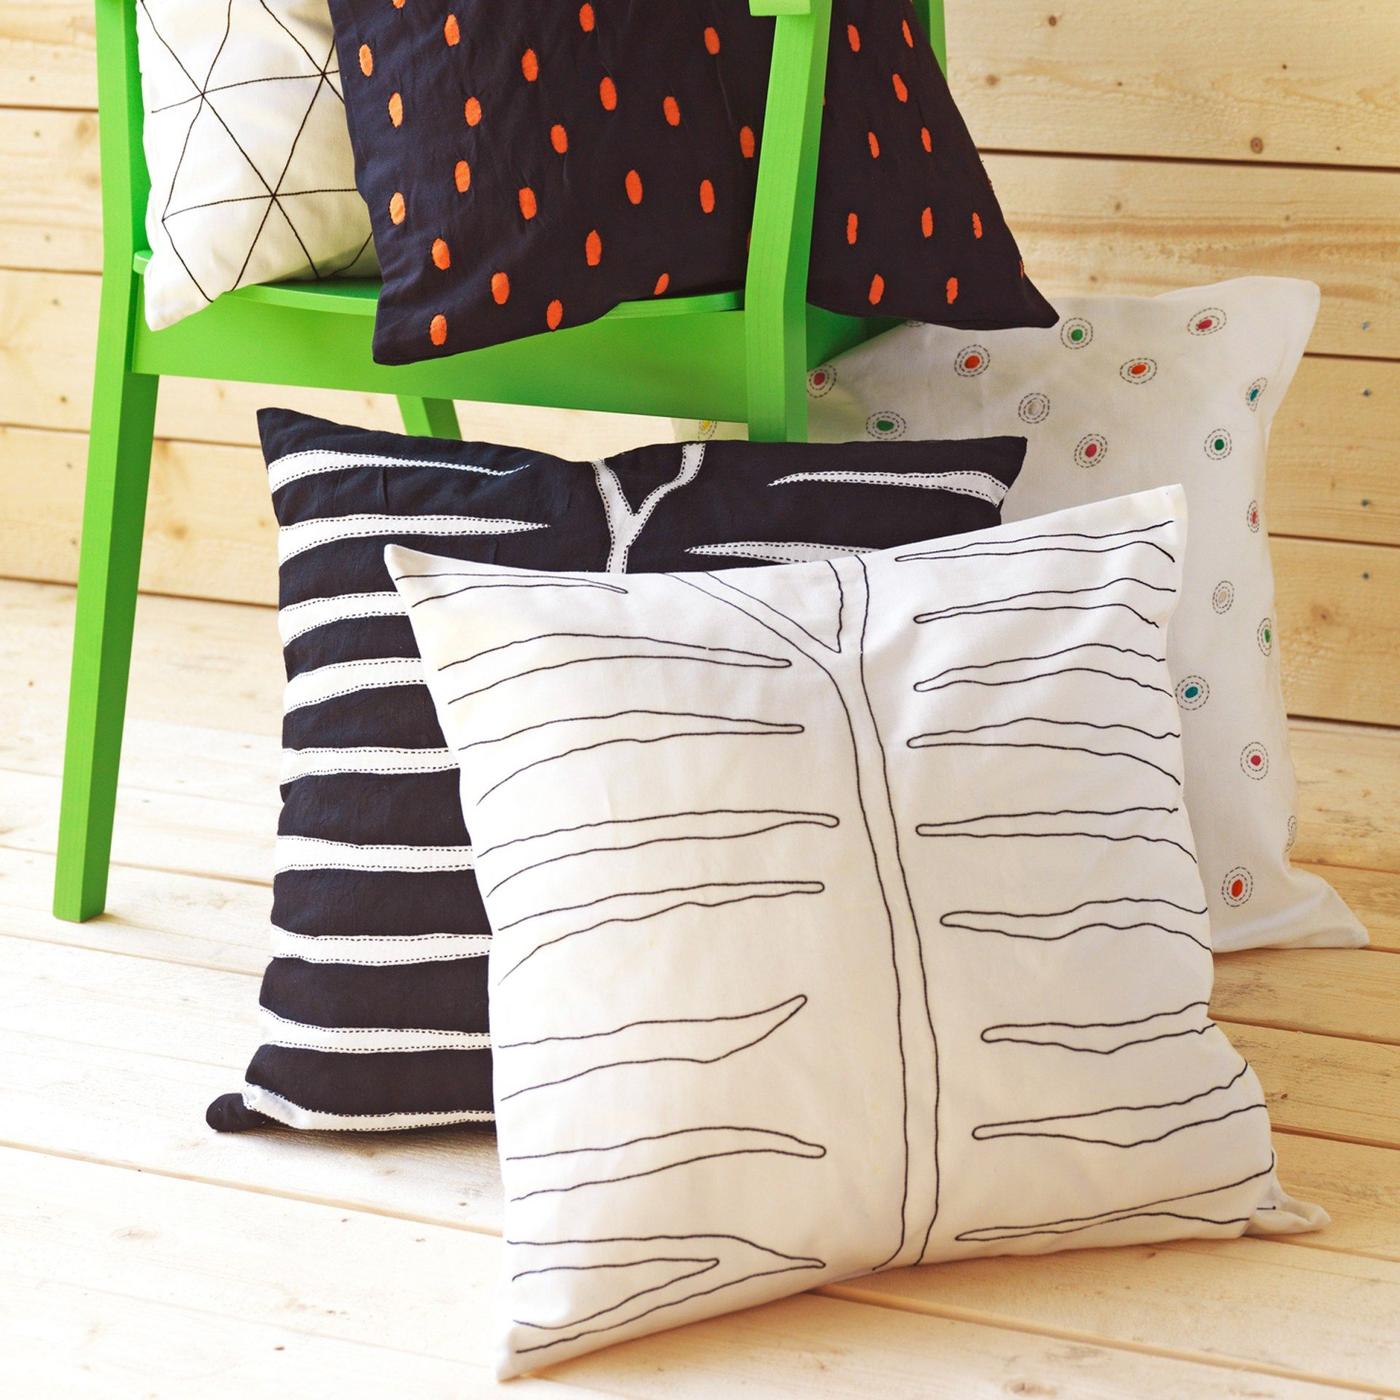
[946, 0, 1400, 165]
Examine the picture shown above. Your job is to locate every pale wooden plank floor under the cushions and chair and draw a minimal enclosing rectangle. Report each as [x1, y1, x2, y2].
[0, 582, 1400, 1400]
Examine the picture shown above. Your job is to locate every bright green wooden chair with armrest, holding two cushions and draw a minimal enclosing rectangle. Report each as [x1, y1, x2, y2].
[53, 0, 944, 921]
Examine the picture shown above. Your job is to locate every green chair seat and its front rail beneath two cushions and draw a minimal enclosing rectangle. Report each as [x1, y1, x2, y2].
[132, 252, 873, 421]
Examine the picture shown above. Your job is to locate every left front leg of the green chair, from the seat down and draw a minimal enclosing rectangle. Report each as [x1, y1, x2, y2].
[53, 286, 160, 923]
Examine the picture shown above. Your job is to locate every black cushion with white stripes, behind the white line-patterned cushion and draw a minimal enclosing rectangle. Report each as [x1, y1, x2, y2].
[209, 410, 1025, 1128]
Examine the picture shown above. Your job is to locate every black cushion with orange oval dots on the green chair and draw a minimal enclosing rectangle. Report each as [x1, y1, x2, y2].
[330, 0, 1054, 364]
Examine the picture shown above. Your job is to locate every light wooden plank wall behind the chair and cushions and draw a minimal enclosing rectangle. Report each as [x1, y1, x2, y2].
[0, 0, 1400, 725]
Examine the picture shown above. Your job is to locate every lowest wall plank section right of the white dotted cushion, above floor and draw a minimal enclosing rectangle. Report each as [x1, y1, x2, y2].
[1273, 539, 1400, 725]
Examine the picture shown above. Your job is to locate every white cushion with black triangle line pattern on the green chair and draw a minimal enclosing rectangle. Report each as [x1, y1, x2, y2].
[136, 0, 377, 330]
